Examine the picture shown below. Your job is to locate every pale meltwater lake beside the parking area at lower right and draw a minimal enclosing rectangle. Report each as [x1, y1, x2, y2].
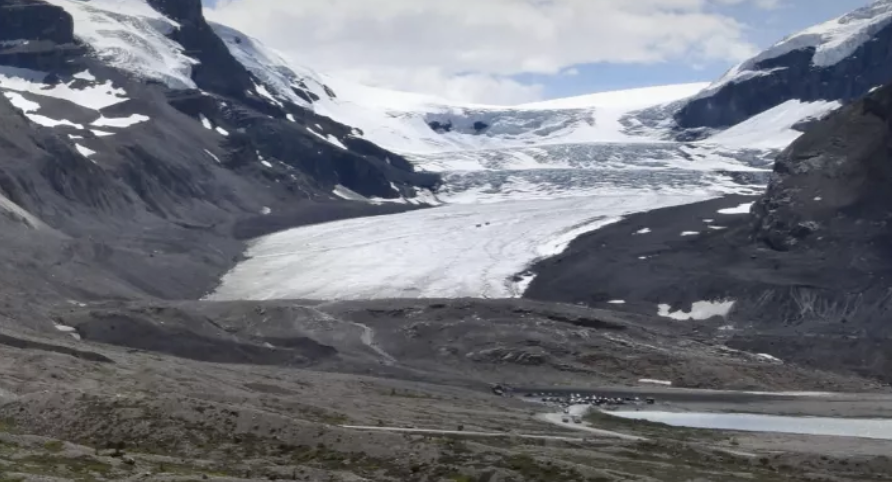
[606, 411, 892, 440]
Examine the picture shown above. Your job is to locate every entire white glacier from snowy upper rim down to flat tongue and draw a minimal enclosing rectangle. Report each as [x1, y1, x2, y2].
[200, 15, 852, 300]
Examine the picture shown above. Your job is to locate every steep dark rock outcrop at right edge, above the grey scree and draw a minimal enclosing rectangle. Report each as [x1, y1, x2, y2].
[753, 82, 892, 255]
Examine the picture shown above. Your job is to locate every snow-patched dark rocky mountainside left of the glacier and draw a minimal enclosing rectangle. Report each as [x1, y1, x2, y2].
[0, 0, 438, 312]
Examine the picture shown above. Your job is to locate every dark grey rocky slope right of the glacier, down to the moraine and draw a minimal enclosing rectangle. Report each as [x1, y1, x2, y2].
[526, 77, 892, 380]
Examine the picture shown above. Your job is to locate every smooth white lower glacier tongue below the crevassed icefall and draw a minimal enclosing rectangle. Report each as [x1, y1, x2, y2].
[209, 193, 709, 300]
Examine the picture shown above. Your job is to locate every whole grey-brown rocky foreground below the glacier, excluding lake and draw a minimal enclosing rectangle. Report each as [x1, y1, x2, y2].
[0, 300, 890, 482]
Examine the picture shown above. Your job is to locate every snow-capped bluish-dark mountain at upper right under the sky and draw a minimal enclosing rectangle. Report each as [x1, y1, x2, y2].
[674, 0, 892, 129]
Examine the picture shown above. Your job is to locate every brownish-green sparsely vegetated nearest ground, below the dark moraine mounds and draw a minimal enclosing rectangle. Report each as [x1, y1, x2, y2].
[0, 324, 892, 482]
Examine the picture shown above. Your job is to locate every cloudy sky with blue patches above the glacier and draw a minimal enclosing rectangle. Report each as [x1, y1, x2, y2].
[203, 0, 872, 105]
